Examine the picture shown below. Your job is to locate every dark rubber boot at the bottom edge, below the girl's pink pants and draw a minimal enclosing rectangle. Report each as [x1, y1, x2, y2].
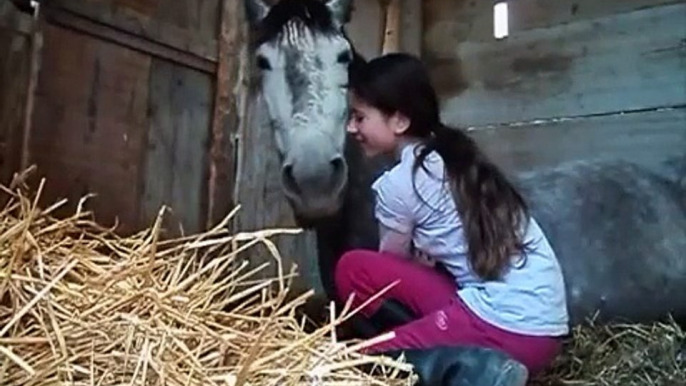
[380, 346, 529, 386]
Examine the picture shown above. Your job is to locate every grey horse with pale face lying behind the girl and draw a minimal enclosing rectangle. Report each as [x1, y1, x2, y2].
[244, 0, 686, 325]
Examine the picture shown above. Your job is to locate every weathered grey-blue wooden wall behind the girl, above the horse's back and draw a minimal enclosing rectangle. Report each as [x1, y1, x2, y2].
[423, 0, 686, 178]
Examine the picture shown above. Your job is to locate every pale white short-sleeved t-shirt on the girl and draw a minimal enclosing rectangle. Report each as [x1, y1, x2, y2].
[372, 144, 569, 336]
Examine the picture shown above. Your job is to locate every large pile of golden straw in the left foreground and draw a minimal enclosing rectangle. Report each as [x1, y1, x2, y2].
[0, 170, 412, 386]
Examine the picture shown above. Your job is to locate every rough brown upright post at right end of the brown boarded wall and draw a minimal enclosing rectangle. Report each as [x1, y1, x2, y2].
[206, 0, 242, 228]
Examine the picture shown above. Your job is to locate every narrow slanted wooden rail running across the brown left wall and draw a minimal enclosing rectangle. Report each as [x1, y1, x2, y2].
[44, 8, 217, 74]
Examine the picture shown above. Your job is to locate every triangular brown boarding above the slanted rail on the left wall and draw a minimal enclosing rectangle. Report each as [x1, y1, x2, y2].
[50, 0, 219, 62]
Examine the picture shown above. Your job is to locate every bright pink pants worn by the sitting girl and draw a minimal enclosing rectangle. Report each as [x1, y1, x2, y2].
[335, 250, 561, 375]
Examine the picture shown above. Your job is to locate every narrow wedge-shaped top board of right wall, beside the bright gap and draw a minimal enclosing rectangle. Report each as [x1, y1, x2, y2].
[508, 0, 683, 34]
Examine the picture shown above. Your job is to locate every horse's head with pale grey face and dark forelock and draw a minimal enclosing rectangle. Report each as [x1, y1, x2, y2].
[244, 0, 362, 226]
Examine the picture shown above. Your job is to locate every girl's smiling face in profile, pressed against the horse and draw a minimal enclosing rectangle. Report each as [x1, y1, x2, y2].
[347, 94, 410, 157]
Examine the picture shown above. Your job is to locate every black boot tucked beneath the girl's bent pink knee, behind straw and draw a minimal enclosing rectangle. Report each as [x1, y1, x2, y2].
[348, 299, 416, 339]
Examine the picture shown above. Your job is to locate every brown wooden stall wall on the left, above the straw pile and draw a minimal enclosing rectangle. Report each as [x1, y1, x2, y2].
[0, 0, 242, 237]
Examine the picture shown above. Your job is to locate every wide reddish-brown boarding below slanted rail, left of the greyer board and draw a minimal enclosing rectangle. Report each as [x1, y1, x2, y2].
[30, 25, 150, 233]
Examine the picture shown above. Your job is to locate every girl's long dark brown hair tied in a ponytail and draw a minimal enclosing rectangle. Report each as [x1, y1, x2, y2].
[350, 53, 529, 280]
